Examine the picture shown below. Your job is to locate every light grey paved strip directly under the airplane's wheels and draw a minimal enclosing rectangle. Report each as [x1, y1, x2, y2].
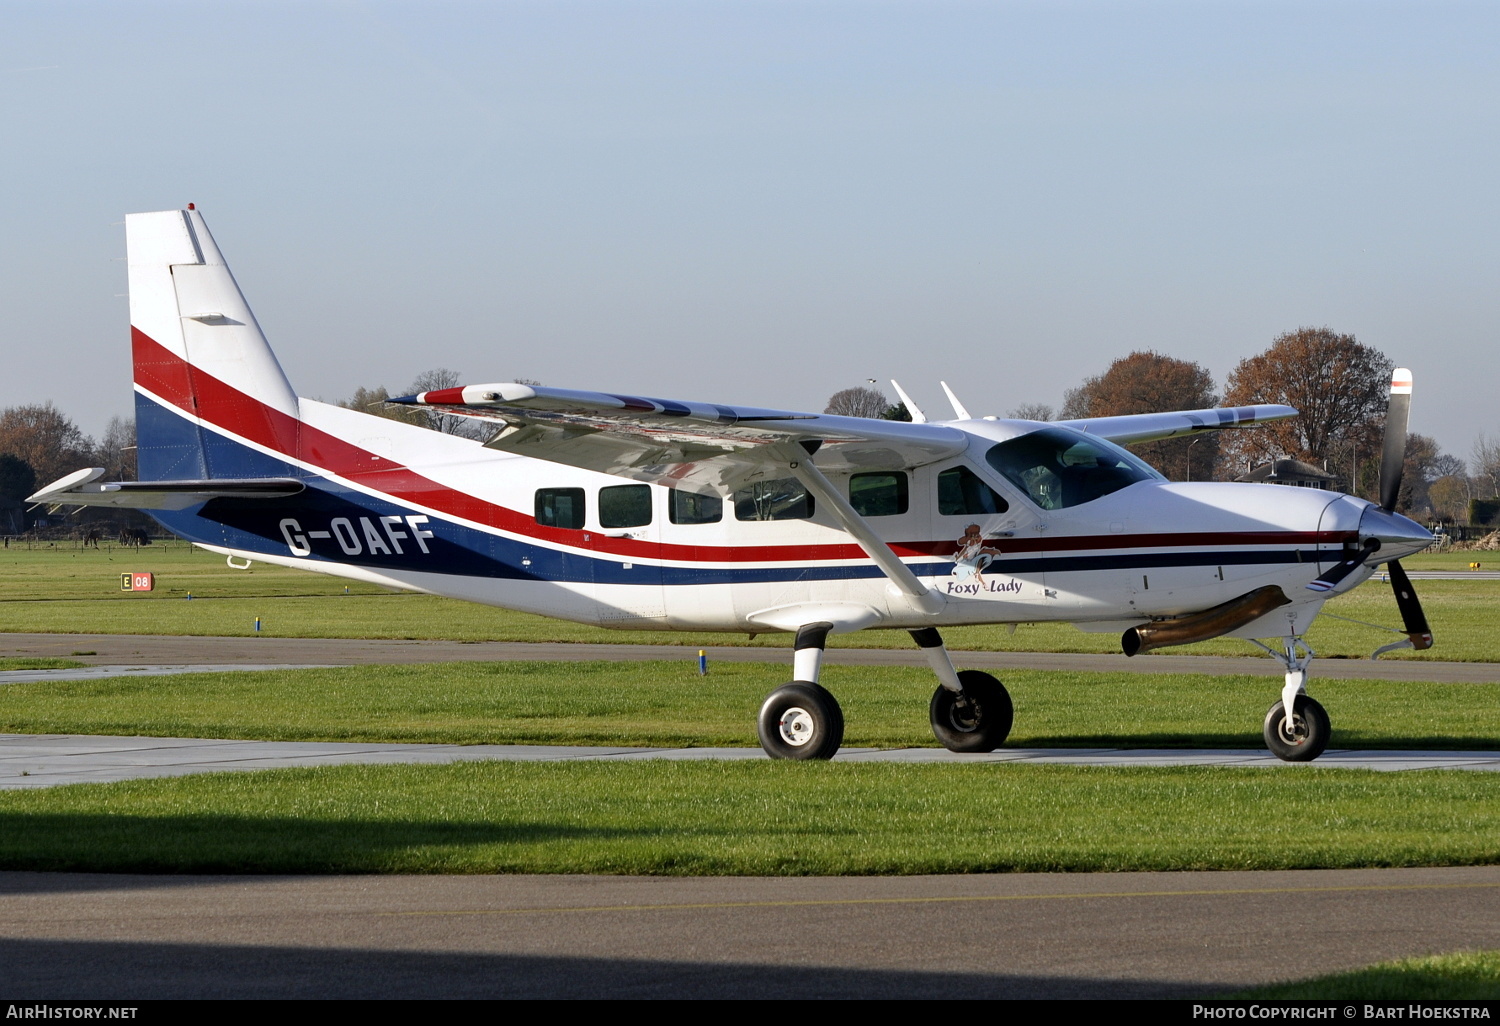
[0, 734, 1500, 791]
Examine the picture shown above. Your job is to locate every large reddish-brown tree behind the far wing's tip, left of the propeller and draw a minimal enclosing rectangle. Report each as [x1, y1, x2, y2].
[1223, 327, 1392, 497]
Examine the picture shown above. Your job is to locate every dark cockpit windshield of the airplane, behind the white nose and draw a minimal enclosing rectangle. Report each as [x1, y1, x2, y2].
[984, 428, 1166, 510]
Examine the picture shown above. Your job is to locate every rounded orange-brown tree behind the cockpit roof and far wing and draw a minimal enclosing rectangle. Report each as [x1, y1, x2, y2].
[1061, 353, 1220, 482]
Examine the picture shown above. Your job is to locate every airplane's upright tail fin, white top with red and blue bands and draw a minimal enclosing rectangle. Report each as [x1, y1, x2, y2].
[125, 204, 299, 482]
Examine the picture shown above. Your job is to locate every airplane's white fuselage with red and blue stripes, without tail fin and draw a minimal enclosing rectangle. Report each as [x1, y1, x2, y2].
[178, 399, 1368, 636]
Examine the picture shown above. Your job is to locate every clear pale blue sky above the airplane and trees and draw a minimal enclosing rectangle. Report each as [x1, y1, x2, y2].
[0, 0, 1500, 456]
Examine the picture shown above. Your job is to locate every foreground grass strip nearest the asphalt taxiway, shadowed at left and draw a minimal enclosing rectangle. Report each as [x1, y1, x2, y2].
[0, 762, 1500, 875]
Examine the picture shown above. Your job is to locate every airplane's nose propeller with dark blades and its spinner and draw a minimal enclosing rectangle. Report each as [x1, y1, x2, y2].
[1308, 368, 1433, 659]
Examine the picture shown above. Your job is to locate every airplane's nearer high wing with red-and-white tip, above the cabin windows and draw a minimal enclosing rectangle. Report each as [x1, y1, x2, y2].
[390, 383, 969, 489]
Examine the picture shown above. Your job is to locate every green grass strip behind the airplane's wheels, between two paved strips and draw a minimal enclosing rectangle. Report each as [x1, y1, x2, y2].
[0, 660, 1500, 750]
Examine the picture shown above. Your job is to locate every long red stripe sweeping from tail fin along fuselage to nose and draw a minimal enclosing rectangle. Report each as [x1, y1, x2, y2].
[131, 327, 1355, 563]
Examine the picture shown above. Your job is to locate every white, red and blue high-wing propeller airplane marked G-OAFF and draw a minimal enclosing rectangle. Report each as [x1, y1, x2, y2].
[32, 204, 1433, 762]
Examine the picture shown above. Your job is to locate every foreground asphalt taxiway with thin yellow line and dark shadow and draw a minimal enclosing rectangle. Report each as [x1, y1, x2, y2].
[0, 867, 1500, 1001]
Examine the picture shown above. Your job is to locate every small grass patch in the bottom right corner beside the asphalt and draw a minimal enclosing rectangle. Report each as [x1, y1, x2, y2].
[1226, 951, 1500, 1001]
